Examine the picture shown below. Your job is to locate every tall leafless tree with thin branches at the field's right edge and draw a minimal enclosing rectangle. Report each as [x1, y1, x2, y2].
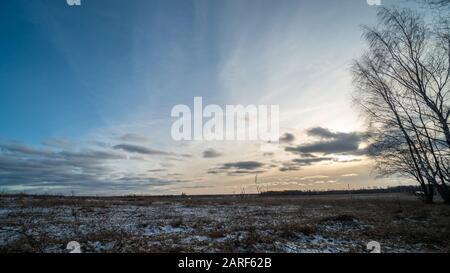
[352, 8, 450, 203]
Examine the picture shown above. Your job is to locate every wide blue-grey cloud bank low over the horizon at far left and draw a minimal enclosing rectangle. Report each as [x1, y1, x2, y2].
[0, 142, 179, 194]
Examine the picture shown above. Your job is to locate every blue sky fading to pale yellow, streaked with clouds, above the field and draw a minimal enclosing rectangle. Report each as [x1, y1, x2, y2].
[0, 0, 418, 195]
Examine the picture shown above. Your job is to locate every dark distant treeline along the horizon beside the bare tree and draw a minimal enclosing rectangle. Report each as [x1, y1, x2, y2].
[261, 186, 420, 196]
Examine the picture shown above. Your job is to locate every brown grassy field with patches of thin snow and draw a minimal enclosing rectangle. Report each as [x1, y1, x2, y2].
[0, 191, 450, 253]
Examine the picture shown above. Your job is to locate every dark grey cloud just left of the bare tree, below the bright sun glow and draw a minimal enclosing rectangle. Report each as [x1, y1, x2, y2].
[285, 127, 367, 155]
